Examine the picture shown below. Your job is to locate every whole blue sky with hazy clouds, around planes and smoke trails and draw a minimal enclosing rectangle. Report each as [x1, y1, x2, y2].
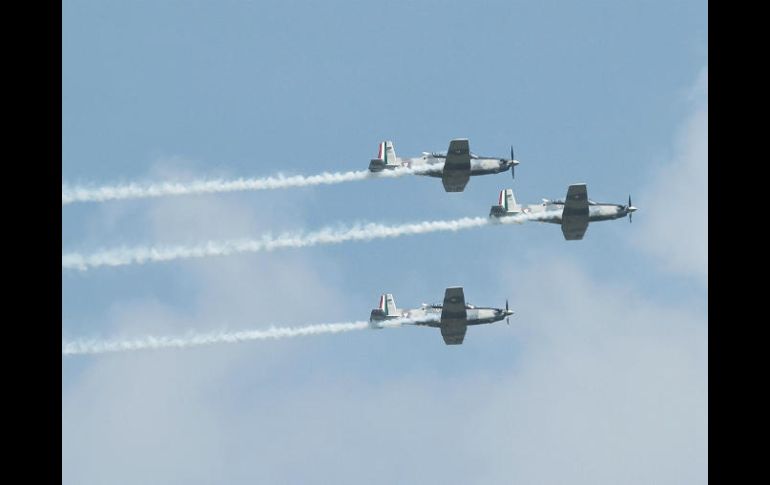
[62, 1, 708, 483]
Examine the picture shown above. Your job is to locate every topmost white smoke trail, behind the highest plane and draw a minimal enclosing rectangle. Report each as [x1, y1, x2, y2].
[61, 165, 442, 205]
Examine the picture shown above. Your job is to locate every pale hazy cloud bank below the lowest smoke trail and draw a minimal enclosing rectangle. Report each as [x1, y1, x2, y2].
[63, 248, 708, 484]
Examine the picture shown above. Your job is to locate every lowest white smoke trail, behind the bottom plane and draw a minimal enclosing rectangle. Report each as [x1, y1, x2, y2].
[61, 316, 438, 356]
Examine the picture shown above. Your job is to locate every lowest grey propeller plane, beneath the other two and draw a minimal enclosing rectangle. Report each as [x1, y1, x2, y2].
[369, 286, 513, 345]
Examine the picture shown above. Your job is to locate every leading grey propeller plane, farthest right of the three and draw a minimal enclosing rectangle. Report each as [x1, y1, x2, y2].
[489, 184, 637, 241]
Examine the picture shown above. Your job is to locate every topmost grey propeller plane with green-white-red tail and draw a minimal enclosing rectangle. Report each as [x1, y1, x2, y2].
[369, 138, 519, 192]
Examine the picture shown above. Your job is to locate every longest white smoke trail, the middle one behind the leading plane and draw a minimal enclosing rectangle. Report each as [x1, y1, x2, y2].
[62, 213, 550, 271]
